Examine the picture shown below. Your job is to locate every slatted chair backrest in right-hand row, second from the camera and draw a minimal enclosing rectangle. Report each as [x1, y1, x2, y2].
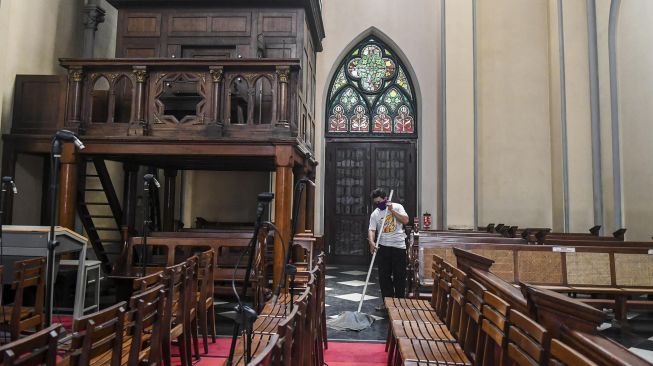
[508, 309, 550, 366]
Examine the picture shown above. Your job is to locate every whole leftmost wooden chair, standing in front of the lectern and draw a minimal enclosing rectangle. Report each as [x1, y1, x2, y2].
[0, 257, 46, 341]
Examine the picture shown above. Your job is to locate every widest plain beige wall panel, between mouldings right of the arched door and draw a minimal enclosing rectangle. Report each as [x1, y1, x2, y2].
[474, 0, 552, 227]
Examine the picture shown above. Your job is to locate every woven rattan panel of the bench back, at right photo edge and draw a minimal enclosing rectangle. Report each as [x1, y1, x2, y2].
[614, 253, 653, 286]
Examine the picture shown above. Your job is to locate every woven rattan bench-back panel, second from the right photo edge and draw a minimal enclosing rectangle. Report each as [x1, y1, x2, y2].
[566, 253, 612, 286]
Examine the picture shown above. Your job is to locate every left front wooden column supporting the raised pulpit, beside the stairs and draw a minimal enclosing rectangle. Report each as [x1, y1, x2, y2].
[59, 142, 77, 230]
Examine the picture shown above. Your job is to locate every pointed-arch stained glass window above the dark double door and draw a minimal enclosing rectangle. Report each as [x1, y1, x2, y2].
[326, 36, 417, 138]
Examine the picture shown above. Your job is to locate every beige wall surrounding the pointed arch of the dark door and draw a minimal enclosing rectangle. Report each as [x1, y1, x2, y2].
[315, 0, 440, 233]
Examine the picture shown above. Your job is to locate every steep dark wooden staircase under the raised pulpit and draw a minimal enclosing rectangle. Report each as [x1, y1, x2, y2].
[77, 157, 123, 274]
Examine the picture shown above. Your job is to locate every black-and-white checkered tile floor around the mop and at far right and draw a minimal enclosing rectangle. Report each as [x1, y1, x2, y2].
[326, 265, 653, 363]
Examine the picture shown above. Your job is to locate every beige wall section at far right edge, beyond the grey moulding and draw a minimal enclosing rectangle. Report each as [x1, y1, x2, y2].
[617, 0, 653, 240]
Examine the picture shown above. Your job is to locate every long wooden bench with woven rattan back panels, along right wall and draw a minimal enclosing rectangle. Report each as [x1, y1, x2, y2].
[420, 243, 653, 326]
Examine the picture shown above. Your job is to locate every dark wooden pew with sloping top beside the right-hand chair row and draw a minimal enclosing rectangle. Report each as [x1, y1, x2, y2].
[454, 249, 649, 366]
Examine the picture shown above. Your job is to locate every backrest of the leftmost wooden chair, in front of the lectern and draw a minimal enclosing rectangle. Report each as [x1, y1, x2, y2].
[11, 257, 46, 323]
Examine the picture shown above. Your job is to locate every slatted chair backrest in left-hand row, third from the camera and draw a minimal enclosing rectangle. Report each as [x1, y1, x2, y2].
[128, 285, 166, 365]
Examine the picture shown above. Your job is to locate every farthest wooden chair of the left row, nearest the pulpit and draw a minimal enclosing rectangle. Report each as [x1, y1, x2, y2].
[197, 249, 216, 353]
